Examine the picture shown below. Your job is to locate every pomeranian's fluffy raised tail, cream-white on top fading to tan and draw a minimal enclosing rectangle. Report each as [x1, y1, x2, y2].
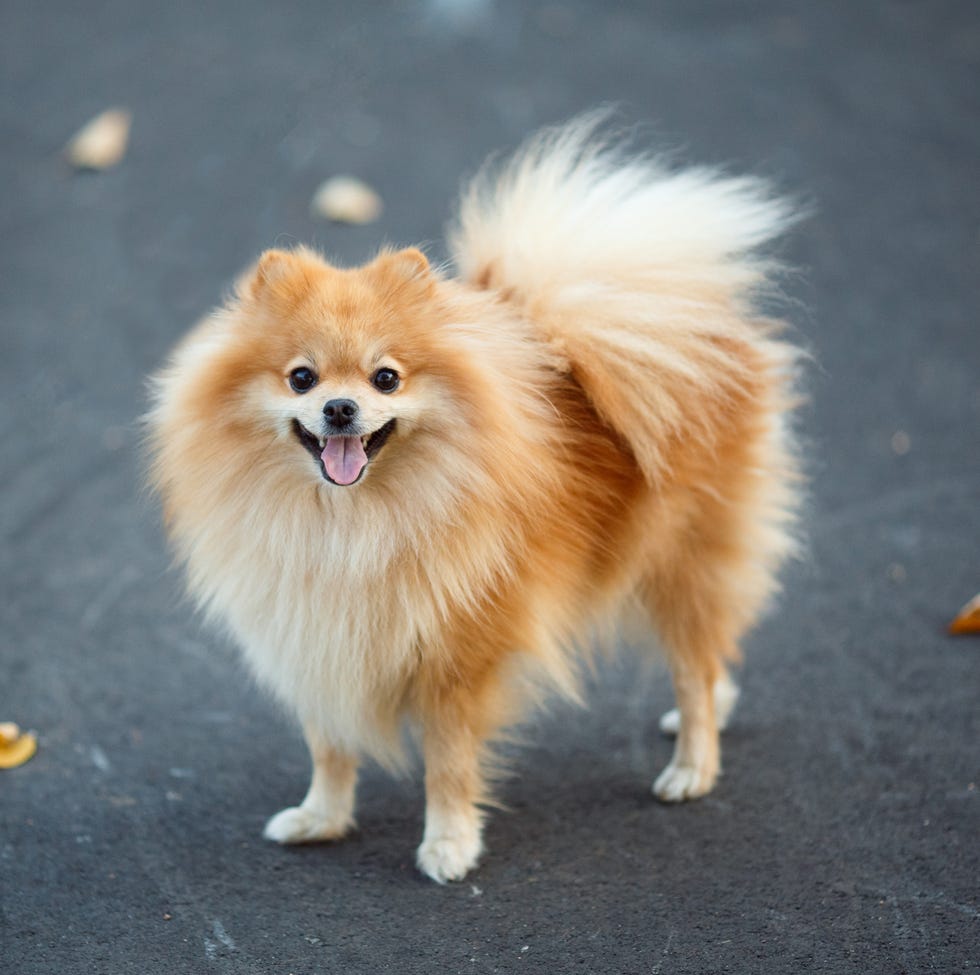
[450, 114, 796, 482]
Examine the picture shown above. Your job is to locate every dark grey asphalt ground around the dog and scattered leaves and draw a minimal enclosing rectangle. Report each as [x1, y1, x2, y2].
[0, 0, 980, 975]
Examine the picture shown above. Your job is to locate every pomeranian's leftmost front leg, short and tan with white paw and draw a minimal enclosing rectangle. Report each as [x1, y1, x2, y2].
[263, 726, 357, 843]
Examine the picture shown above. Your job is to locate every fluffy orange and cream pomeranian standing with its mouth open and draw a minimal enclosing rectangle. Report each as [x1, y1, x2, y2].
[149, 118, 798, 882]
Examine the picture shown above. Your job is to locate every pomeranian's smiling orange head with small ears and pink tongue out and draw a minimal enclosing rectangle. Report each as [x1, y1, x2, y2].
[207, 250, 460, 488]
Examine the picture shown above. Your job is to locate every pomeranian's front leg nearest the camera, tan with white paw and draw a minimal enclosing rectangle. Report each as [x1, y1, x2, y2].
[418, 706, 484, 884]
